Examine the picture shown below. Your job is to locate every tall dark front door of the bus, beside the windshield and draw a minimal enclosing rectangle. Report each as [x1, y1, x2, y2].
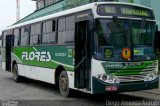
[75, 21, 91, 89]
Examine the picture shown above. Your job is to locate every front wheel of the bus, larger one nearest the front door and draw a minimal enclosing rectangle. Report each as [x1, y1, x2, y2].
[59, 71, 71, 97]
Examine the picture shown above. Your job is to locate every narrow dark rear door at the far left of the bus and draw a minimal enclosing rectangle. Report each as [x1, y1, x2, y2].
[5, 35, 14, 71]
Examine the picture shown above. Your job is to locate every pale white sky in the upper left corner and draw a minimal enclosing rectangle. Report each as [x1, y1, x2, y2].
[0, 0, 36, 35]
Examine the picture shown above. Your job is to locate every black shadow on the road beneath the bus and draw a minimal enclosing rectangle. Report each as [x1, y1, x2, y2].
[16, 78, 146, 105]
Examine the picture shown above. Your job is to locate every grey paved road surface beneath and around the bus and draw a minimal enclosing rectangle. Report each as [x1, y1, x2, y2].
[0, 66, 160, 106]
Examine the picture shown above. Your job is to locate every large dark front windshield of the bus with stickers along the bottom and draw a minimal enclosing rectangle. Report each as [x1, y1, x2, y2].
[94, 19, 156, 61]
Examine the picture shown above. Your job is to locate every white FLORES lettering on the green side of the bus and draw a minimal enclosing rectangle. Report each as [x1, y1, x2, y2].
[22, 52, 51, 62]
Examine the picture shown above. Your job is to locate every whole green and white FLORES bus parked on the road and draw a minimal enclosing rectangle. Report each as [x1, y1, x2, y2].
[2, 2, 159, 96]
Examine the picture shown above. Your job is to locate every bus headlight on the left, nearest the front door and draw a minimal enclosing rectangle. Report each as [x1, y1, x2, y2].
[96, 74, 120, 83]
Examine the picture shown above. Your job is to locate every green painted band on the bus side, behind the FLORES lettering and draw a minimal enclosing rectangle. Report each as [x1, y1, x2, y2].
[13, 46, 74, 71]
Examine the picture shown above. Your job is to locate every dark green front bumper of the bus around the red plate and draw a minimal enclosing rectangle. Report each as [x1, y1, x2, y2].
[92, 77, 159, 94]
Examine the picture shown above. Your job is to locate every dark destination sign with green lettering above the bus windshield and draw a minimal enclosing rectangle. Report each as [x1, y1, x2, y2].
[97, 4, 154, 19]
